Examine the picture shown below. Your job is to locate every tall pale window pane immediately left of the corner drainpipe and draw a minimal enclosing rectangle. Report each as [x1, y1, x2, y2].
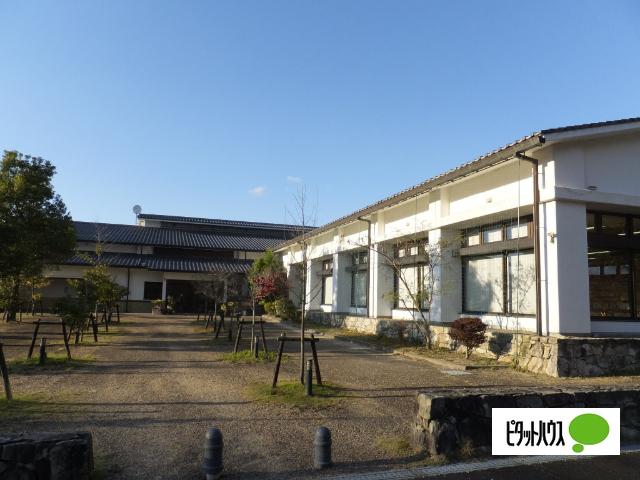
[507, 252, 536, 315]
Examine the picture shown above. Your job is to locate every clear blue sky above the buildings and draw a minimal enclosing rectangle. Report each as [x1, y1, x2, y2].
[0, 0, 640, 224]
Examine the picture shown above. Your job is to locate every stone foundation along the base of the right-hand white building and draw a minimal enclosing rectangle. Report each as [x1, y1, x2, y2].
[307, 311, 640, 377]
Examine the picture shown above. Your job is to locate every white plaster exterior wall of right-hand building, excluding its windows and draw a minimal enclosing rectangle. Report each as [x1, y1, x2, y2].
[281, 129, 640, 335]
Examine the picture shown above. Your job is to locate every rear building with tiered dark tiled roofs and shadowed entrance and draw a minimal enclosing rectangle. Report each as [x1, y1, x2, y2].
[42, 213, 301, 313]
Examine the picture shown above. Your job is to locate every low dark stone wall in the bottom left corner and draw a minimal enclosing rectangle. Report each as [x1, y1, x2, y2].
[0, 432, 93, 480]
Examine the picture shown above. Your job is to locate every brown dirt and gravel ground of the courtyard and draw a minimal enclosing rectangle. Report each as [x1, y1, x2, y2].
[0, 316, 640, 479]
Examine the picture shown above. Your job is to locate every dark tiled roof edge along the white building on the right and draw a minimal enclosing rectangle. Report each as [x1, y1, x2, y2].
[278, 117, 640, 249]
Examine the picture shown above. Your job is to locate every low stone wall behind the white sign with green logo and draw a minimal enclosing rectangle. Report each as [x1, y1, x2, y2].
[412, 390, 640, 455]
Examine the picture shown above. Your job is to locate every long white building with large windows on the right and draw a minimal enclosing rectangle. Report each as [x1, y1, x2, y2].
[277, 118, 640, 336]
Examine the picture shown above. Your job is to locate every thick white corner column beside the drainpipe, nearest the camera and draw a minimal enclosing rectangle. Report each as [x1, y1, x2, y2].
[539, 201, 591, 335]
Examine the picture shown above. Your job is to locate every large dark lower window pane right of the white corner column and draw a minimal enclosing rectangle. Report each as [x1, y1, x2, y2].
[589, 248, 631, 318]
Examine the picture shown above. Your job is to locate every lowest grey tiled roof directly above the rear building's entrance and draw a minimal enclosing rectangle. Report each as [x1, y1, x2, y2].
[64, 253, 252, 273]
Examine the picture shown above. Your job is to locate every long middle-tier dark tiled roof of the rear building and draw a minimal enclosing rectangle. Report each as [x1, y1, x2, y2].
[73, 222, 282, 252]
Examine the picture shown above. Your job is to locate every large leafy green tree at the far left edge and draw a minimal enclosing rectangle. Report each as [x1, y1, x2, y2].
[0, 151, 75, 320]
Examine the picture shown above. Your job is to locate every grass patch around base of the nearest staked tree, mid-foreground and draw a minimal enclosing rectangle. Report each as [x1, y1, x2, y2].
[247, 382, 345, 408]
